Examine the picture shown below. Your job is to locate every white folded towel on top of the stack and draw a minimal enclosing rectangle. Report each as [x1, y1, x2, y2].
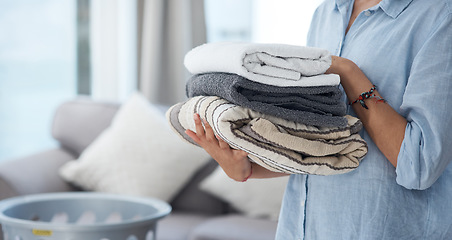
[184, 42, 340, 87]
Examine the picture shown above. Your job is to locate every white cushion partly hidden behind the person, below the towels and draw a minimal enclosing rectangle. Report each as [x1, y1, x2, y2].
[200, 167, 289, 220]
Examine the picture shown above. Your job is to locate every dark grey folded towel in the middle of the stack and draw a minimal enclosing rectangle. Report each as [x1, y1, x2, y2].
[186, 73, 347, 127]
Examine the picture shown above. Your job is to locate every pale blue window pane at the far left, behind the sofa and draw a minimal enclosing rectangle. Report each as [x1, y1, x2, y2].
[0, 0, 76, 161]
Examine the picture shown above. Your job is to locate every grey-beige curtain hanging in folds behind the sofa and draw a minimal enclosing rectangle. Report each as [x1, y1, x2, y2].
[138, 0, 206, 105]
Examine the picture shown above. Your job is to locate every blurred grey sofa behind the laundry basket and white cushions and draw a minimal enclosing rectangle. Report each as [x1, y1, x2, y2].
[0, 97, 277, 240]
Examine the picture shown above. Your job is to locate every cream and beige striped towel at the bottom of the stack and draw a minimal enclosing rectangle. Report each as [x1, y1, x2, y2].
[166, 96, 367, 175]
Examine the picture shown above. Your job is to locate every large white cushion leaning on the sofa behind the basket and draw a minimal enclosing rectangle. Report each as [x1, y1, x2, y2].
[60, 93, 209, 201]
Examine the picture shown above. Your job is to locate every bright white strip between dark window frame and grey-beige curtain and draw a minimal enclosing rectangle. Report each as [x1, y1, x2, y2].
[89, 0, 138, 101]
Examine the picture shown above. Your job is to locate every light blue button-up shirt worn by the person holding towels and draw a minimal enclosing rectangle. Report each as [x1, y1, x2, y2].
[276, 0, 452, 240]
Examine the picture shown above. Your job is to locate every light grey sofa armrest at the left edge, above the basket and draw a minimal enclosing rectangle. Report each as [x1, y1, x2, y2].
[0, 149, 75, 200]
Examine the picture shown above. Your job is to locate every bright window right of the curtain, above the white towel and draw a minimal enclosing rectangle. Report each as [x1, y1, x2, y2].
[205, 0, 322, 45]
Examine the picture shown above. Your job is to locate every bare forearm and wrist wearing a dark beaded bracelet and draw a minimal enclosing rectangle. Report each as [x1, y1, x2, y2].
[328, 56, 407, 166]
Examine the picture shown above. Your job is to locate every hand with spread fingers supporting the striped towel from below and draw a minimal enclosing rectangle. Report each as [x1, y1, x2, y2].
[185, 114, 252, 182]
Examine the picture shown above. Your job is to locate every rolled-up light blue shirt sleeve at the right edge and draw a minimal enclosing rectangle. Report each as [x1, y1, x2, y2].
[396, 14, 452, 190]
